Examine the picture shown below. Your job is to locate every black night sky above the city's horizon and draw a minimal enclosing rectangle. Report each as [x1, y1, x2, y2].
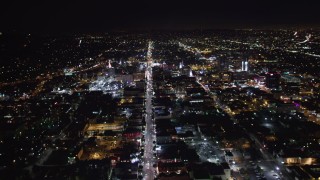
[0, 0, 320, 32]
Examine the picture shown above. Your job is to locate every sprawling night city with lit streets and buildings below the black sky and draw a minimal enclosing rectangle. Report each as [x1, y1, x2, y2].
[0, 29, 320, 180]
